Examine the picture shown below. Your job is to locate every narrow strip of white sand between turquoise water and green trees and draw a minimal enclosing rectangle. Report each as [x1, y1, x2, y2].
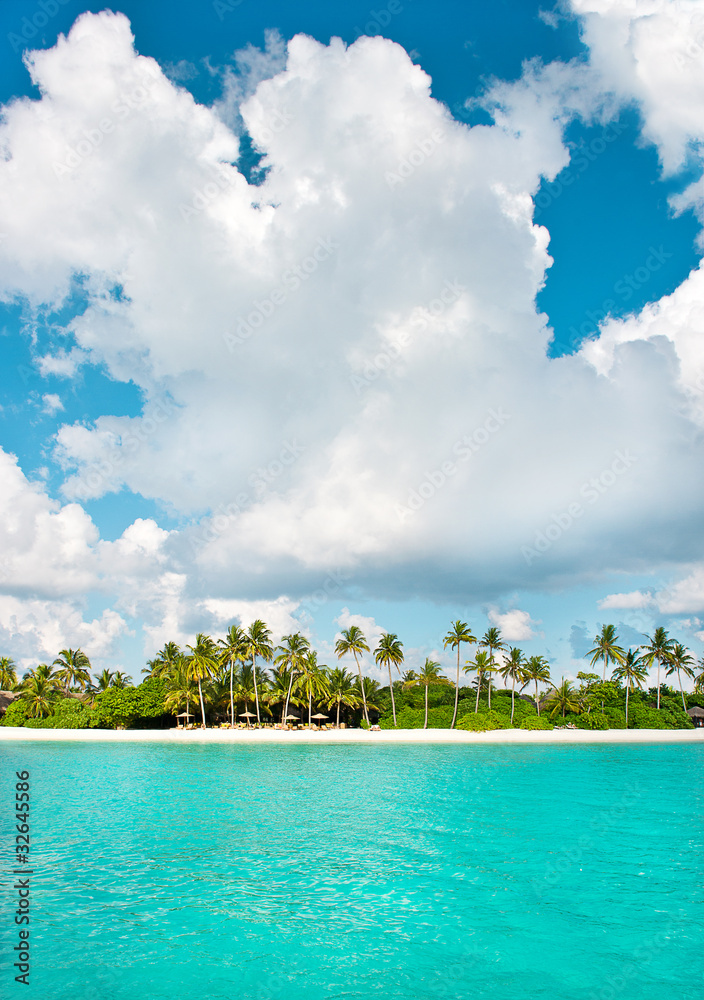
[0, 726, 704, 746]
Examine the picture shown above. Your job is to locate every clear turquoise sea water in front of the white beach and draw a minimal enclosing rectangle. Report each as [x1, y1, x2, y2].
[0, 743, 704, 1000]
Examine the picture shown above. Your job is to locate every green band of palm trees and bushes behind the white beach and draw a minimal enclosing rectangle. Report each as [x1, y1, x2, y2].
[0, 619, 704, 732]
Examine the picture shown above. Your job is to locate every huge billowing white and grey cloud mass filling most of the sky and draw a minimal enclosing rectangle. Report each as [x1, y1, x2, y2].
[0, 11, 704, 668]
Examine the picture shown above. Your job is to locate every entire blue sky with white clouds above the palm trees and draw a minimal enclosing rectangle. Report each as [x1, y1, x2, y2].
[0, 0, 704, 677]
